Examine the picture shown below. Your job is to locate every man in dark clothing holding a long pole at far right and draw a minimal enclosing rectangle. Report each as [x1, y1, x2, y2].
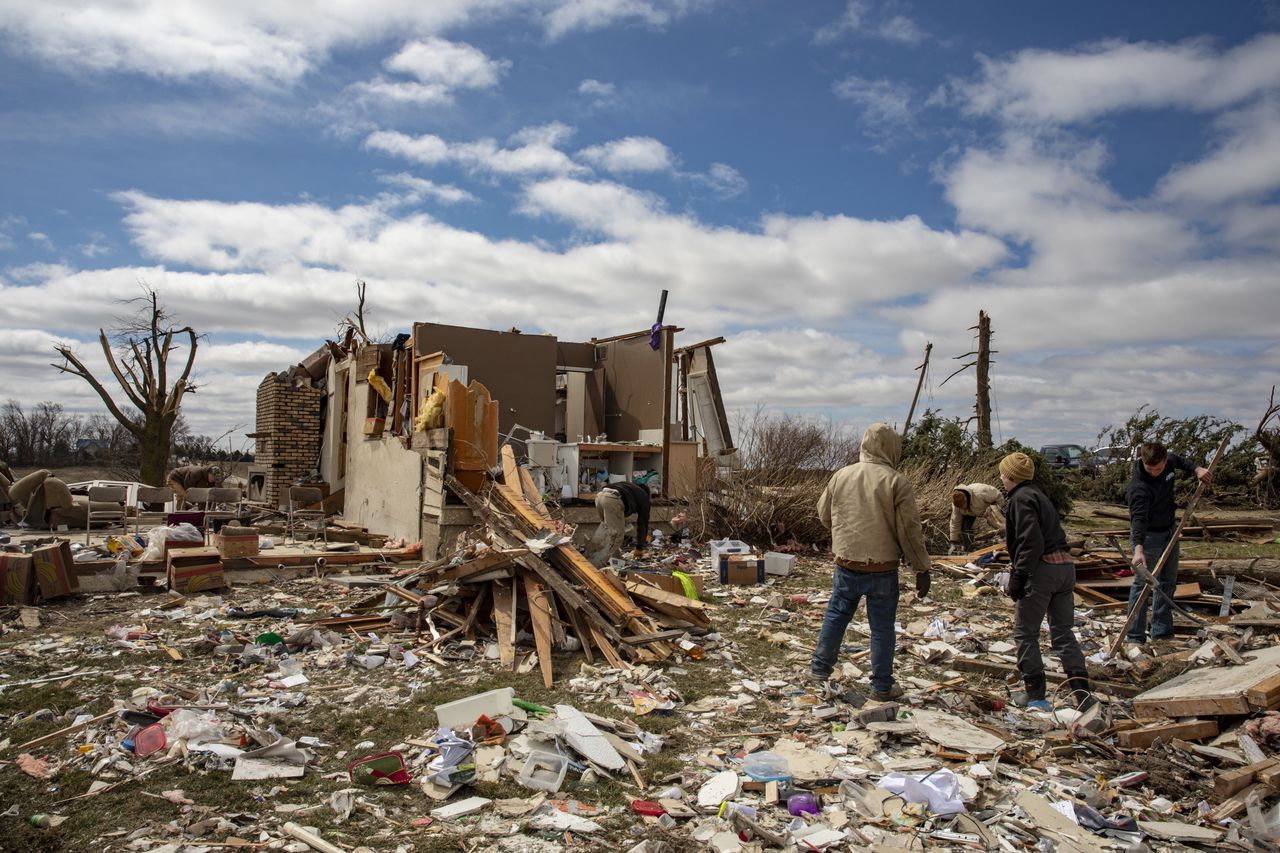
[1125, 442, 1210, 643]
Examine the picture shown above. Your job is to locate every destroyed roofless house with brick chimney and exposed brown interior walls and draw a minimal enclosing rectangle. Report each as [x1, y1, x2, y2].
[250, 323, 736, 557]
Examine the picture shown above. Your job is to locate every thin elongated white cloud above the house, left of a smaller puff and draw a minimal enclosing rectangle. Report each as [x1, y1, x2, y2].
[365, 124, 584, 177]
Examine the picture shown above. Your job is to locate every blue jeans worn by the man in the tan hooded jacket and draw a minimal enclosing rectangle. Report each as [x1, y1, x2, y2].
[809, 566, 897, 693]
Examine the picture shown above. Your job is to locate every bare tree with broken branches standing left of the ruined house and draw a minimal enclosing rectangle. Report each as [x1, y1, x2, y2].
[52, 288, 197, 485]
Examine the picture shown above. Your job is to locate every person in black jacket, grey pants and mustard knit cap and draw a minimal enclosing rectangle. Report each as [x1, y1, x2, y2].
[1000, 453, 1089, 711]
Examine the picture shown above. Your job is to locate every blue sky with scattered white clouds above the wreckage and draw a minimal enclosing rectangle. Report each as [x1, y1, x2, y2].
[0, 0, 1280, 444]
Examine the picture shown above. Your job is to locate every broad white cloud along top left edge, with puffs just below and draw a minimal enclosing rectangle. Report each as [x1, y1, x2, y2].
[0, 0, 713, 85]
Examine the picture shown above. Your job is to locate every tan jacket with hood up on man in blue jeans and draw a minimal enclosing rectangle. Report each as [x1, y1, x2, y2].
[818, 424, 931, 571]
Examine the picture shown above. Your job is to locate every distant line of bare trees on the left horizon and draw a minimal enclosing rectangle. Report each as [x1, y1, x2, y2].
[0, 400, 253, 476]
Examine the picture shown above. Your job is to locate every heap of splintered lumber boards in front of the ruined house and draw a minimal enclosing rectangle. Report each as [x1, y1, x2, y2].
[309, 446, 712, 686]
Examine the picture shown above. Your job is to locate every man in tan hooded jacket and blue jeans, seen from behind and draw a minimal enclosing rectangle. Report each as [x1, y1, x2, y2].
[809, 424, 931, 702]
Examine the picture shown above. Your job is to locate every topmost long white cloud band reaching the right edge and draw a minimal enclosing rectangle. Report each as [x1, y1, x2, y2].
[954, 33, 1280, 123]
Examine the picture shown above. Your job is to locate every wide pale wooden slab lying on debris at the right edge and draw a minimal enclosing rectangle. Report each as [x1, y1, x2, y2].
[1133, 646, 1280, 720]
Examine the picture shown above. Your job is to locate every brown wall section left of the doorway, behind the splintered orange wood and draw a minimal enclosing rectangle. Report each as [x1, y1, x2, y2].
[413, 323, 558, 441]
